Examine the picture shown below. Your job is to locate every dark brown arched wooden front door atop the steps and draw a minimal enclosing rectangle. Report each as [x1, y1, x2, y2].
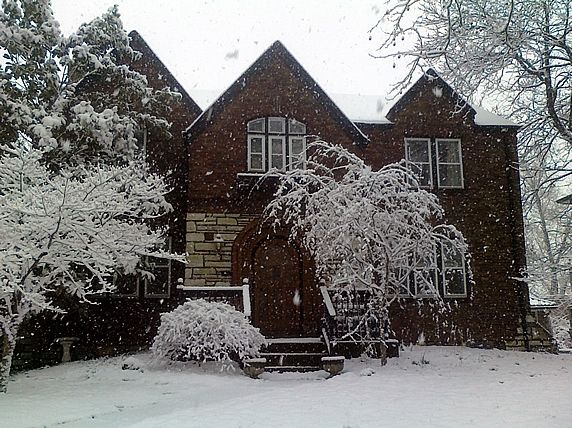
[252, 239, 303, 337]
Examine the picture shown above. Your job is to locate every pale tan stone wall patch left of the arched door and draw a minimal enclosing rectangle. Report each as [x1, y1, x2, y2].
[184, 213, 256, 287]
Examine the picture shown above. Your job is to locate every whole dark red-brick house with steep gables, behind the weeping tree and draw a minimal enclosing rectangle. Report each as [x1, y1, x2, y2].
[15, 32, 532, 368]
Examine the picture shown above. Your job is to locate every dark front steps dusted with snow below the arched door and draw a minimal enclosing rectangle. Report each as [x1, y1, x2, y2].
[260, 337, 328, 372]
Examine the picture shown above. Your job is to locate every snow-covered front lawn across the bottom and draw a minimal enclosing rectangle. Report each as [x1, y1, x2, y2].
[0, 347, 572, 428]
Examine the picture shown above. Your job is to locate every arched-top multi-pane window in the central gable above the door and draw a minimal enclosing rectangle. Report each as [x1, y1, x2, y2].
[247, 117, 306, 172]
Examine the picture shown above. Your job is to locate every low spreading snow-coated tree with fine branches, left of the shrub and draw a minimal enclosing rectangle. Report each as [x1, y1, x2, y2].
[0, 145, 181, 392]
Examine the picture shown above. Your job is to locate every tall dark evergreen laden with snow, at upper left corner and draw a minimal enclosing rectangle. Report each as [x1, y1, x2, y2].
[0, 0, 176, 165]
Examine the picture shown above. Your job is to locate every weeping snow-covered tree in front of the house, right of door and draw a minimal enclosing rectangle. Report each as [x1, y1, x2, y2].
[262, 141, 468, 340]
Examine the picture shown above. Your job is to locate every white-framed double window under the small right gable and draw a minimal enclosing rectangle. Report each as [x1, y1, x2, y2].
[405, 138, 464, 188]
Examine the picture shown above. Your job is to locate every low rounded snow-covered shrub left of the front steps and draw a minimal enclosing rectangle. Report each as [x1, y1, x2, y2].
[151, 299, 265, 363]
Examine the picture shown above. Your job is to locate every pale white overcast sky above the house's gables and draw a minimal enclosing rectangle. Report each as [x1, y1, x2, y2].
[53, 0, 399, 103]
